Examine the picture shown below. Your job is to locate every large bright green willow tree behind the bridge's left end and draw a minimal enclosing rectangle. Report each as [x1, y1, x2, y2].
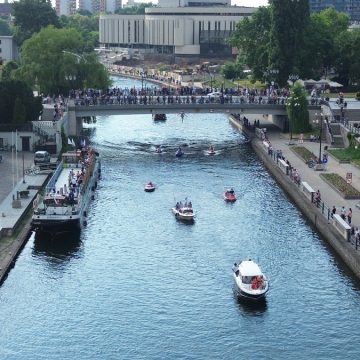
[16, 26, 110, 94]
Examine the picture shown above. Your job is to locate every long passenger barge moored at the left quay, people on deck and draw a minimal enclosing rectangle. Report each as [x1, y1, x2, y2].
[31, 149, 101, 232]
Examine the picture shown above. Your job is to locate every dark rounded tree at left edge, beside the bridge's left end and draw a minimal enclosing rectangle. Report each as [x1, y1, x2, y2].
[0, 80, 42, 124]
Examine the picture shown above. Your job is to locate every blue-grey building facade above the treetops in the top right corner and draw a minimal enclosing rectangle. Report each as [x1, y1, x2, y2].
[309, 0, 360, 22]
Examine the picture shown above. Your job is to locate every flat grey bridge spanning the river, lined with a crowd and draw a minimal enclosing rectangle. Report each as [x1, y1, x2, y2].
[64, 96, 321, 135]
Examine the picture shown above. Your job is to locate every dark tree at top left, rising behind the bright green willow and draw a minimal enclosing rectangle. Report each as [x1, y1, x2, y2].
[12, 0, 60, 45]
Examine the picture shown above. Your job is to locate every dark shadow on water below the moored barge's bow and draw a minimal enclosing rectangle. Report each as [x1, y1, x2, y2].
[33, 230, 82, 260]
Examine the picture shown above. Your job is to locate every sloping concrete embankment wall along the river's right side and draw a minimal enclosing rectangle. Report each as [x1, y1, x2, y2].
[230, 117, 360, 279]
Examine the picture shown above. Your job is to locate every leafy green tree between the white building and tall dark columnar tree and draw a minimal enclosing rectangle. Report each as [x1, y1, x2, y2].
[229, 7, 271, 79]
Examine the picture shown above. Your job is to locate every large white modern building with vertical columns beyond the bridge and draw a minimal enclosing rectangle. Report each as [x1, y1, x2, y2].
[99, 0, 257, 59]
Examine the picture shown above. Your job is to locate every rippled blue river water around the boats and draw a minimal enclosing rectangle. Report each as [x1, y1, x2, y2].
[0, 80, 360, 360]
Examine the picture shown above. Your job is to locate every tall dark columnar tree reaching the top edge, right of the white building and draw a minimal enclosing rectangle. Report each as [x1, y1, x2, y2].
[268, 0, 310, 85]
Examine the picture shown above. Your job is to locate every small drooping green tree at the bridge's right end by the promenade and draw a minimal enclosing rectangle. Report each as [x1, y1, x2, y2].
[286, 82, 311, 133]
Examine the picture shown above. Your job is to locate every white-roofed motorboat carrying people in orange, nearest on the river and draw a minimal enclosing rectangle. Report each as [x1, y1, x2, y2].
[233, 259, 269, 300]
